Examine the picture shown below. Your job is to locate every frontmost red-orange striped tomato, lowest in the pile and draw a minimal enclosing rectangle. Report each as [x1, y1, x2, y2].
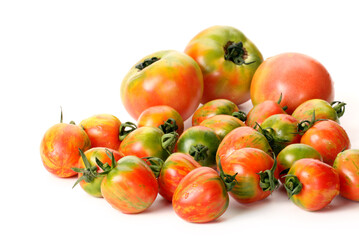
[172, 167, 229, 223]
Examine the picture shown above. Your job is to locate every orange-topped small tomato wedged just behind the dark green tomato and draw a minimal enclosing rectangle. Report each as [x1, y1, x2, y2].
[200, 115, 245, 140]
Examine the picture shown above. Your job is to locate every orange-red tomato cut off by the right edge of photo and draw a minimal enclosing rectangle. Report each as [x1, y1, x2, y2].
[333, 149, 359, 201]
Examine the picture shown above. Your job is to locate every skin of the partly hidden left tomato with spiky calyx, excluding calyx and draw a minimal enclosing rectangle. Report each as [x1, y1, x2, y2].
[78, 147, 123, 197]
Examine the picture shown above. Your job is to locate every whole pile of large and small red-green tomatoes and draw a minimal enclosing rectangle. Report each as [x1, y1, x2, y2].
[40, 26, 359, 222]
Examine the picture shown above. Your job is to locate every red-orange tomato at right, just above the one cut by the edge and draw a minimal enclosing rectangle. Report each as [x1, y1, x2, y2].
[300, 120, 350, 166]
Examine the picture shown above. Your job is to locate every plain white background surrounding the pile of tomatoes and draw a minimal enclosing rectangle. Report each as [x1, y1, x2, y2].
[0, 0, 359, 239]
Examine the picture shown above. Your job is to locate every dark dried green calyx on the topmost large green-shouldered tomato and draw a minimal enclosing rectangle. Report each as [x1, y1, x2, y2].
[224, 41, 255, 65]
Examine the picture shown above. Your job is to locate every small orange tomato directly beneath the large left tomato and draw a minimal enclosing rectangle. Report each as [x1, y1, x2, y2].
[137, 105, 184, 134]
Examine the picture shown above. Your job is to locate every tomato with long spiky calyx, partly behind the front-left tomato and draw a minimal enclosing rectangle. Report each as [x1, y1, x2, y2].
[72, 147, 123, 197]
